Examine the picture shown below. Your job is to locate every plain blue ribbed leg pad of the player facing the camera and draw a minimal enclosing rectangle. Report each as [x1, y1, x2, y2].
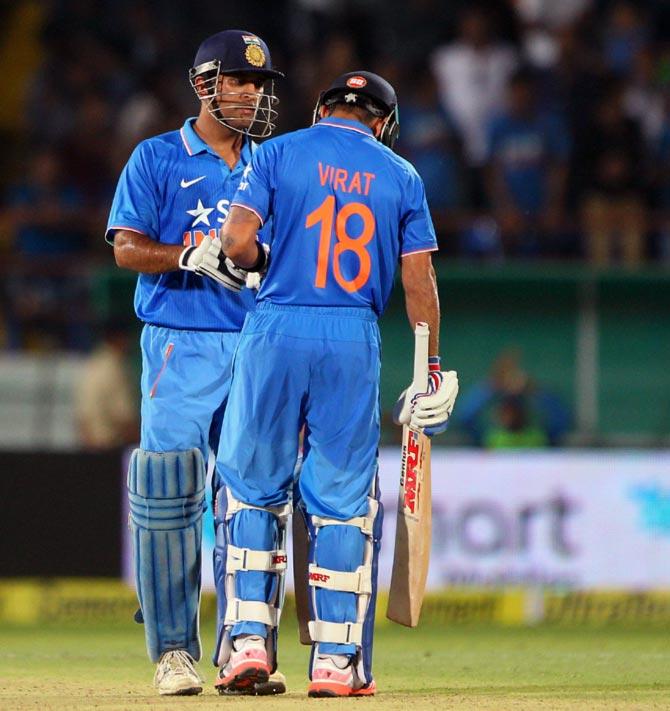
[128, 449, 205, 662]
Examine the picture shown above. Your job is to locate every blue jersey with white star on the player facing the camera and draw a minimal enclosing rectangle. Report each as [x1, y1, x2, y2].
[105, 118, 255, 331]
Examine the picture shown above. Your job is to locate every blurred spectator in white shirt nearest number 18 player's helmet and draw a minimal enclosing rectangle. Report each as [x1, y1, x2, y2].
[432, 6, 517, 207]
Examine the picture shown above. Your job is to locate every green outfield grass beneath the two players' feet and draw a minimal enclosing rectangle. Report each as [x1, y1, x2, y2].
[0, 620, 670, 711]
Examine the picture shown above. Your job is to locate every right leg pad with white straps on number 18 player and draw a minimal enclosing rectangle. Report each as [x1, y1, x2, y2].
[305, 484, 384, 683]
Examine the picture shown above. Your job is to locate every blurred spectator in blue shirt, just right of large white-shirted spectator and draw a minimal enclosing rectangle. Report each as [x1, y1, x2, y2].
[488, 69, 570, 256]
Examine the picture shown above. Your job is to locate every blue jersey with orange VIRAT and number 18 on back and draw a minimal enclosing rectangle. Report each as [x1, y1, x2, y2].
[233, 118, 437, 314]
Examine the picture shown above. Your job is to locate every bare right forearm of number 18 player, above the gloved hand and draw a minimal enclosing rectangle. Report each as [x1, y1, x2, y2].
[402, 254, 440, 356]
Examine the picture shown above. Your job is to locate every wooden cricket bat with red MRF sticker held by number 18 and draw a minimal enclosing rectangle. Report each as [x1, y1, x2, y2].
[386, 322, 432, 627]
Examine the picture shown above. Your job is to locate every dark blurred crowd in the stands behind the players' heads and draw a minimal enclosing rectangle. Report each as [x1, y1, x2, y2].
[0, 0, 670, 349]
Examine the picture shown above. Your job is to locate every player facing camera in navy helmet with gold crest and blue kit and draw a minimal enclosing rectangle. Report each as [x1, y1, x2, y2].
[106, 30, 283, 695]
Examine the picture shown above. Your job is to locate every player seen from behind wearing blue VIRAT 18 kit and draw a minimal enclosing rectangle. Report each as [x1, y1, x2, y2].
[215, 71, 458, 696]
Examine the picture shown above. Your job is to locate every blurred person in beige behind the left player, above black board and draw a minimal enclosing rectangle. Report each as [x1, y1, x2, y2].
[75, 323, 140, 451]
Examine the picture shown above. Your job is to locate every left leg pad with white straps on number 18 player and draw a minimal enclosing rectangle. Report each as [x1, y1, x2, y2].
[213, 478, 291, 670]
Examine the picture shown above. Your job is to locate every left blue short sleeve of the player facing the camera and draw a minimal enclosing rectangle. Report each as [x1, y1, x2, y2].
[105, 141, 160, 244]
